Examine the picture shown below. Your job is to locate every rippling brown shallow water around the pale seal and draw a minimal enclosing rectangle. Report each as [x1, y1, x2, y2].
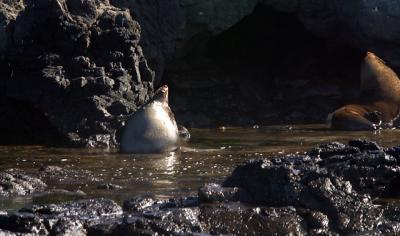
[0, 125, 400, 210]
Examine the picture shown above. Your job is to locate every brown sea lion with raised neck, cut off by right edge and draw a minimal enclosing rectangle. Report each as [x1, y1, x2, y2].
[331, 52, 400, 130]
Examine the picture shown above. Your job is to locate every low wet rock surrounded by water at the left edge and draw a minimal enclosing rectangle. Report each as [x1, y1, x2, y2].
[0, 169, 47, 197]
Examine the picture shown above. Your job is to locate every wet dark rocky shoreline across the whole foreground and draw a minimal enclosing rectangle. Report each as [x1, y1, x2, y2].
[0, 140, 400, 235]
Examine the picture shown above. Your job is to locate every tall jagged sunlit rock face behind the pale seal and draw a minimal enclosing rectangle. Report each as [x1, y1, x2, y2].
[0, 0, 154, 146]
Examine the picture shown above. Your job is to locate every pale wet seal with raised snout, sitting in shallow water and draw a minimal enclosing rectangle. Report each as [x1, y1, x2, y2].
[120, 85, 180, 153]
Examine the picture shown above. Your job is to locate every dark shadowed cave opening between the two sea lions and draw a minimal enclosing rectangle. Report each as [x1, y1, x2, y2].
[166, 5, 364, 127]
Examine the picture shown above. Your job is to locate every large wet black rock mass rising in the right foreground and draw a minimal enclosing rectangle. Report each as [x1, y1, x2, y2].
[224, 140, 400, 234]
